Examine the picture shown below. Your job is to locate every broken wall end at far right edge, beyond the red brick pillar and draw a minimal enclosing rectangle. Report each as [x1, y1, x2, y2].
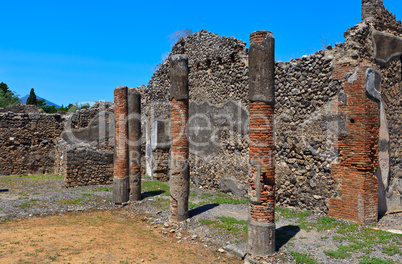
[354, 0, 402, 213]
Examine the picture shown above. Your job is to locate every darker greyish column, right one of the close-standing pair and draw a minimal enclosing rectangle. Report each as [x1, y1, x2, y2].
[127, 88, 141, 201]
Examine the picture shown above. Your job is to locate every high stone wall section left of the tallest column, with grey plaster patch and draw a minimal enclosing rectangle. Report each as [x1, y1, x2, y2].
[143, 31, 248, 187]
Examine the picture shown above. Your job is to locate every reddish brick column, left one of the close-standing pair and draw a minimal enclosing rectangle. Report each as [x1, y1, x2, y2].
[113, 86, 129, 204]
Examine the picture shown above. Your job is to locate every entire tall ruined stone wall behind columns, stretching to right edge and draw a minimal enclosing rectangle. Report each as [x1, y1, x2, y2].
[143, 0, 402, 214]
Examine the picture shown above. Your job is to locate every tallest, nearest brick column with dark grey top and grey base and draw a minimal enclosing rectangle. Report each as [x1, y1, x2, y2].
[248, 31, 275, 256]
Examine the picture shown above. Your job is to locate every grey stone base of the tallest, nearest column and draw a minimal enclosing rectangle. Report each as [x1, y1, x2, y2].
[248, 219, 276, 257]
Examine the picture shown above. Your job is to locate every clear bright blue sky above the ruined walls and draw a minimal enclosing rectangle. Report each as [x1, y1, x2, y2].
[0, 0, 402, 105]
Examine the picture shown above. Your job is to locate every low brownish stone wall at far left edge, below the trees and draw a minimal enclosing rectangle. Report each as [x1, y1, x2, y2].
[0, 109, 65, 175]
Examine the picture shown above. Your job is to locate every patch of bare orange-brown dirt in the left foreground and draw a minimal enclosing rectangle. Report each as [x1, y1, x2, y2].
[0, 209, 241, 263]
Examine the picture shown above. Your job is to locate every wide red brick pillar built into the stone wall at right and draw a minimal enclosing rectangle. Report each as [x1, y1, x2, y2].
[328, 63, 379, 224]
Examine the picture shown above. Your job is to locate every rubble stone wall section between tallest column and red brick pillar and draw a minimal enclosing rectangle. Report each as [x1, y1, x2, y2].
[275, 52, 342, 211]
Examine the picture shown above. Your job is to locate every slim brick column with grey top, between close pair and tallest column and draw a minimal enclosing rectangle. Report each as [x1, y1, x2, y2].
[169, 55, 190, 222]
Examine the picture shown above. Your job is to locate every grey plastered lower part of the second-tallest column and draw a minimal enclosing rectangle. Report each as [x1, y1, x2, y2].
[169, 162, 190, 222]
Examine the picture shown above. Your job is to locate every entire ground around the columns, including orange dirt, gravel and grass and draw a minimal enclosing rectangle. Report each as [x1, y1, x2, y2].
[0, 175, 402, 264]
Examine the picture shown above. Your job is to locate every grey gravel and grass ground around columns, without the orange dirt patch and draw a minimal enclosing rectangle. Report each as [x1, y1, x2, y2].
[0, 175, 402, 263]
